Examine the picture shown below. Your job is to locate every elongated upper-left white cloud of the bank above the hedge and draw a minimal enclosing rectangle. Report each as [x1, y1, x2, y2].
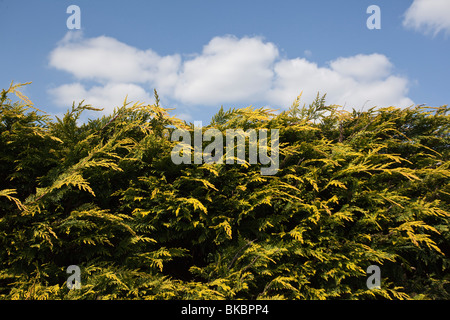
[49, 33, 181, 91]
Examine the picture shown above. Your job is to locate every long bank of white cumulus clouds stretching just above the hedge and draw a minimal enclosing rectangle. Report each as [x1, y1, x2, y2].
[49, 33, 413, 116]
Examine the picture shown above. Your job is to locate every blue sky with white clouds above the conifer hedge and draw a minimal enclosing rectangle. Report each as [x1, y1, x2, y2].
[0, 0, 450, 123]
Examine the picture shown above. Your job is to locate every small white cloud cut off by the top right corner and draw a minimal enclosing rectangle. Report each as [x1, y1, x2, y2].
[403, 0, 450, 35]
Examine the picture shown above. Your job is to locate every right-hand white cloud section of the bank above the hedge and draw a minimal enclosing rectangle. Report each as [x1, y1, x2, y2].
[270, 54, 413, 110]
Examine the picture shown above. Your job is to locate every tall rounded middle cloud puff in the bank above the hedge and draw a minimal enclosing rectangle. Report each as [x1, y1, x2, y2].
[174, 36, 278, 104]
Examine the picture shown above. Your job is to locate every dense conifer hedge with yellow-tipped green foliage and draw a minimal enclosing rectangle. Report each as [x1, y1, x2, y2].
[0, 85, 450, 299]
